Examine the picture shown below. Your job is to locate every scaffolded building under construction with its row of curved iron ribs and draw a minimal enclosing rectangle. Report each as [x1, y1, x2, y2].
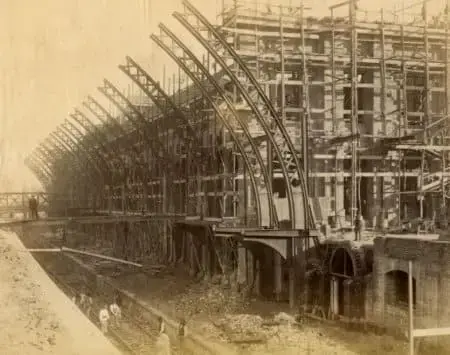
[27, 0, 450, 234]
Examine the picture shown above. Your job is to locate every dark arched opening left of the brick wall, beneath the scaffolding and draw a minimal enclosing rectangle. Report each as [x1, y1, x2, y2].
[330, 248, 355, 315]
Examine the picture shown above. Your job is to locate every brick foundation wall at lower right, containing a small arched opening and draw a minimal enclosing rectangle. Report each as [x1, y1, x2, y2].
[366, 238, 450, 341]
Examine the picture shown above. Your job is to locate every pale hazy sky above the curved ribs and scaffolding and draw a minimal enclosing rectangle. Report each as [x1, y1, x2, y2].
[0, 0, 445, 192]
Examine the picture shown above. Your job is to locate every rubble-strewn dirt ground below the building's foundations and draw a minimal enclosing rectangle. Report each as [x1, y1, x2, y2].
[105, 262, 407, 355]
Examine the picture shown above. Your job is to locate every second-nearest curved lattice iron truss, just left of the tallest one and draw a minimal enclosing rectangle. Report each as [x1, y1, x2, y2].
[152, 24, 278, 227]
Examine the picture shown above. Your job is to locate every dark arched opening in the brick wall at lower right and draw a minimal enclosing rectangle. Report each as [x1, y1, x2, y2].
[385, 270, 416, 308]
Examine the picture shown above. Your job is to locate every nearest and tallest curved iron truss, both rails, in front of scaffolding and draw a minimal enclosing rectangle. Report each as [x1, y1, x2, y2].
[173, 0, 314, 228]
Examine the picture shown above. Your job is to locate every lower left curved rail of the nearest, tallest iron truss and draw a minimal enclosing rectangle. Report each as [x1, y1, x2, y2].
[173, 13, 296, 229]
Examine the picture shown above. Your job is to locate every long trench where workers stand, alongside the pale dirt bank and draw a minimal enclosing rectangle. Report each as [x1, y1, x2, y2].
[15, 230, 191, 355]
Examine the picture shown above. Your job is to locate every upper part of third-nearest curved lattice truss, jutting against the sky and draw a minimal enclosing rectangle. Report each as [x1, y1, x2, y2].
[119, 56, 201, 144]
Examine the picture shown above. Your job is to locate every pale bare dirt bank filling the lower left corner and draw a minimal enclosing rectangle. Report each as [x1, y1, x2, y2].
[0, 230, 120, 355]
